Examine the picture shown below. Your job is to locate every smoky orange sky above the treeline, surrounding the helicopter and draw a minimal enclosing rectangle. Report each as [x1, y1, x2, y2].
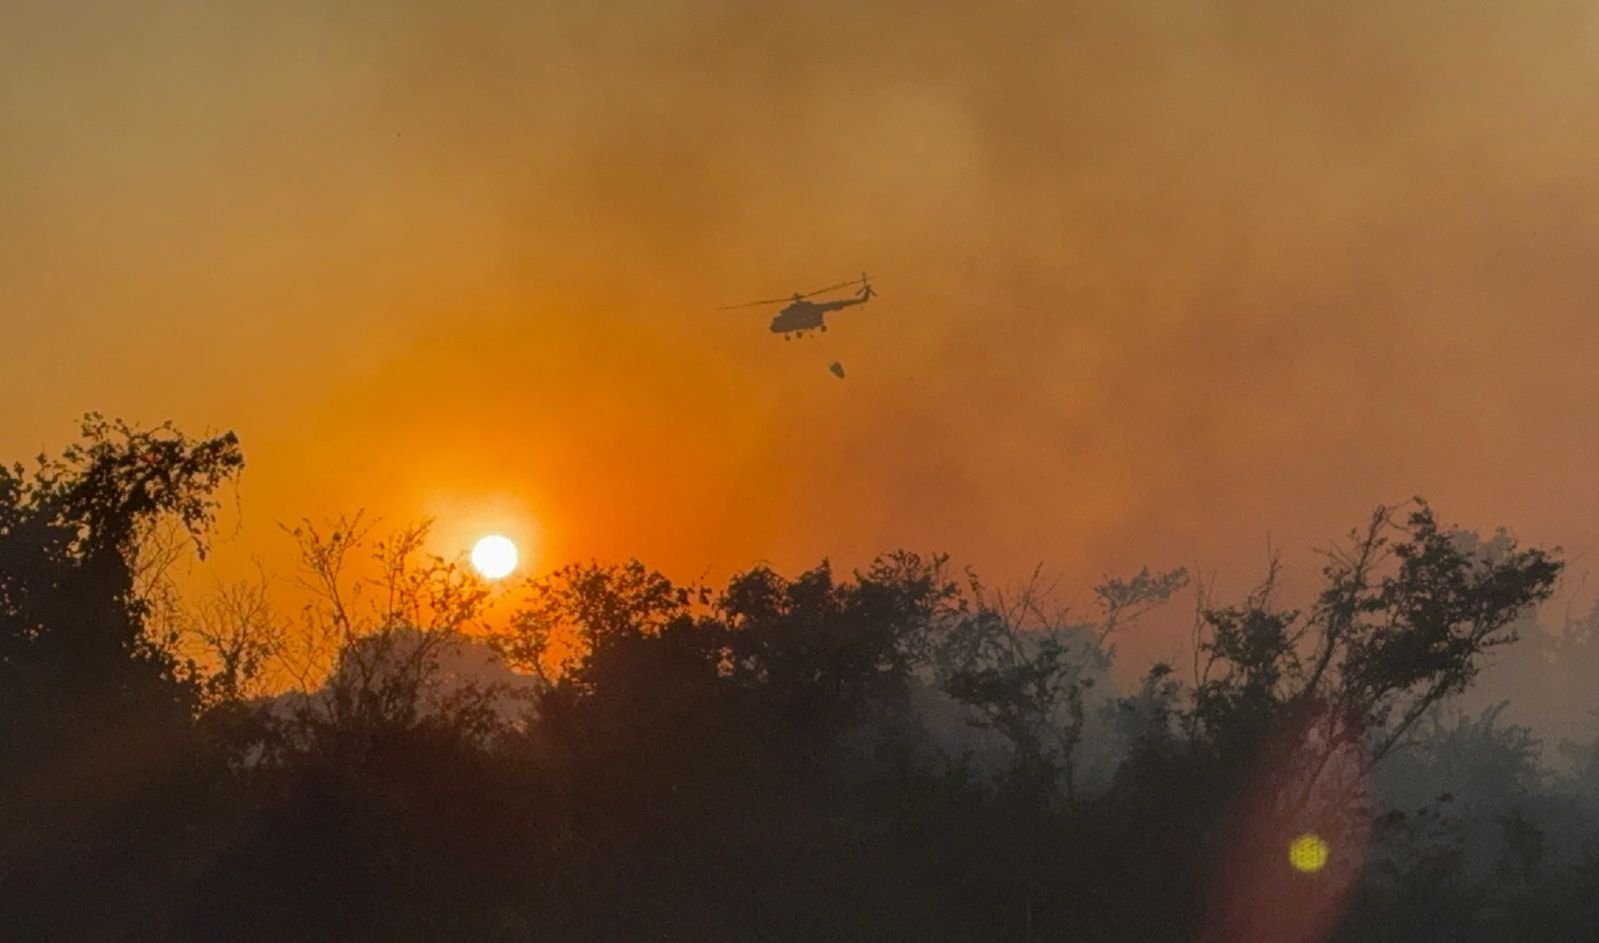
[0, 0, 1599, 664]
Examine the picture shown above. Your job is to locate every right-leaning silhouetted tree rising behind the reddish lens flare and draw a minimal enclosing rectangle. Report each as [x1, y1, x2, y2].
[1100, 502, 1559, 940]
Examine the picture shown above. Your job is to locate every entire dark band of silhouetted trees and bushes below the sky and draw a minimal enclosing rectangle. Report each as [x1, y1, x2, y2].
[0, 417, 1599, 943]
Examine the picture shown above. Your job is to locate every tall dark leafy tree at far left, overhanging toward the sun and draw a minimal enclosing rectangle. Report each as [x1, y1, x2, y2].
[0, 416, 243, 940]
